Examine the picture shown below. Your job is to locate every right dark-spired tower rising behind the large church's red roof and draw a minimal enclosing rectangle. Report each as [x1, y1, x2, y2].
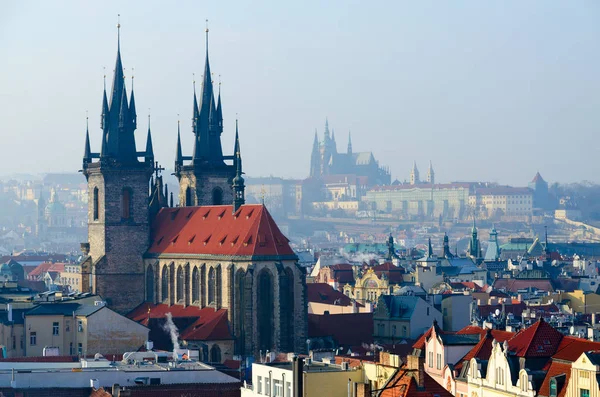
[175, 29, 238, 206]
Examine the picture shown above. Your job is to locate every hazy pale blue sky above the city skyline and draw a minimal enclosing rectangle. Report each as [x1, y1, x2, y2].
[0, 0, 600, 185]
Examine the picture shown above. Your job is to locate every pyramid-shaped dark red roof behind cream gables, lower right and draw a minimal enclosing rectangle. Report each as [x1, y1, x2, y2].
[508, 319, 563, 357]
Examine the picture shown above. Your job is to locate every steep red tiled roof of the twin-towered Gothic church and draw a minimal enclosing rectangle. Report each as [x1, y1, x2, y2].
[148, 204, 296, 259]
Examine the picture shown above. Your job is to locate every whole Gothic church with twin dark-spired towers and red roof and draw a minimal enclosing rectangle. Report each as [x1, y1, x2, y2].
[82, 30, 307, 355]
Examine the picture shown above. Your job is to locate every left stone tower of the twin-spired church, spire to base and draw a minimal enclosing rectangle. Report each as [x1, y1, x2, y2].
[82, 25, 154, 312]
